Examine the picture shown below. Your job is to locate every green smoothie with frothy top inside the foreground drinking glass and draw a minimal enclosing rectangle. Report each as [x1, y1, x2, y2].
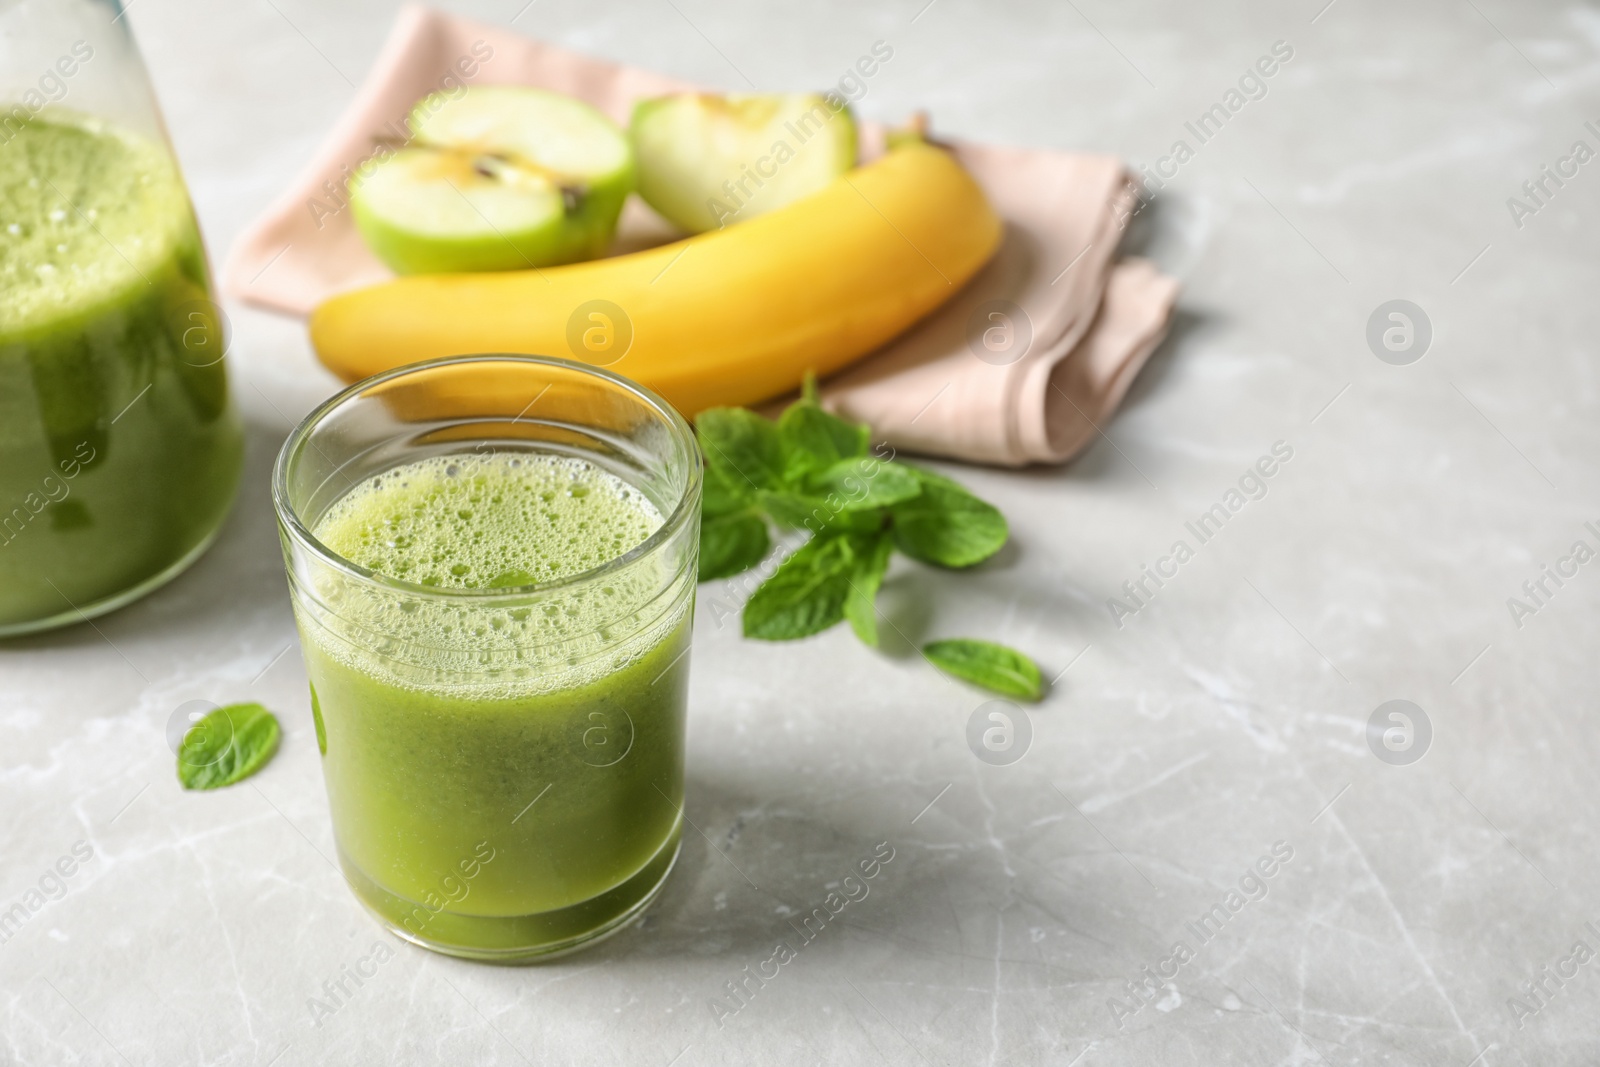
[296, 451, 691, 958]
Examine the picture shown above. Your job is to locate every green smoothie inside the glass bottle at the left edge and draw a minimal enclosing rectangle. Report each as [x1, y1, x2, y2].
[0, 117, 243, 635]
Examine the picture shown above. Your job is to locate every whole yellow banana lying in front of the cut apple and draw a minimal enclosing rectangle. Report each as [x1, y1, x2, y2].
[310, 142, 1002, 416]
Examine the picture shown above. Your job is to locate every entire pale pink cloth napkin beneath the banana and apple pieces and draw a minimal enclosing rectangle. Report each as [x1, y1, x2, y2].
[222, 6, 1178, 466]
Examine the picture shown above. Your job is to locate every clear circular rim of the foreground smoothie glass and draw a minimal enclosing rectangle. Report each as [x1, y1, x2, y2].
[272, 352, 704, 603]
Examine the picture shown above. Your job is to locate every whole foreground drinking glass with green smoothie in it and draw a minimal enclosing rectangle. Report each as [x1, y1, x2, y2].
[272, 355, 701, 961]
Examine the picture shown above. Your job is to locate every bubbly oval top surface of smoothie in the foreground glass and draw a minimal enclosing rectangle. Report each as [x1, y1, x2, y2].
[315, 453, 664, 589]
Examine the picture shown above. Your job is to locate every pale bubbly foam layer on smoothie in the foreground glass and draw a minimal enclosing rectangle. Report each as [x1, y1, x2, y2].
[312, 451, 693, 696]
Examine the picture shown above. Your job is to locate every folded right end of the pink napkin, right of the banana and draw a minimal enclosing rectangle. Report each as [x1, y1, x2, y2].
[822, 144, 1178, 467]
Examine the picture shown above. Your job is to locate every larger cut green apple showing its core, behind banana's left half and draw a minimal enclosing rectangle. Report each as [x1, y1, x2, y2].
[350, 85, 634, 274]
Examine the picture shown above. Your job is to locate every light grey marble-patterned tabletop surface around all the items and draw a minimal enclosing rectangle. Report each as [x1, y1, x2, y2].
[0, 0, 1600, 1067]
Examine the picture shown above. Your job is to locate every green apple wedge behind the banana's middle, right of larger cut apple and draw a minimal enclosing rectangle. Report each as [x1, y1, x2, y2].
[629, 93, 856, 234]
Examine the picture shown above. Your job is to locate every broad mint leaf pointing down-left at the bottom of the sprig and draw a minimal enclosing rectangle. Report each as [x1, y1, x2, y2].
[744, 533, 869, 641]
